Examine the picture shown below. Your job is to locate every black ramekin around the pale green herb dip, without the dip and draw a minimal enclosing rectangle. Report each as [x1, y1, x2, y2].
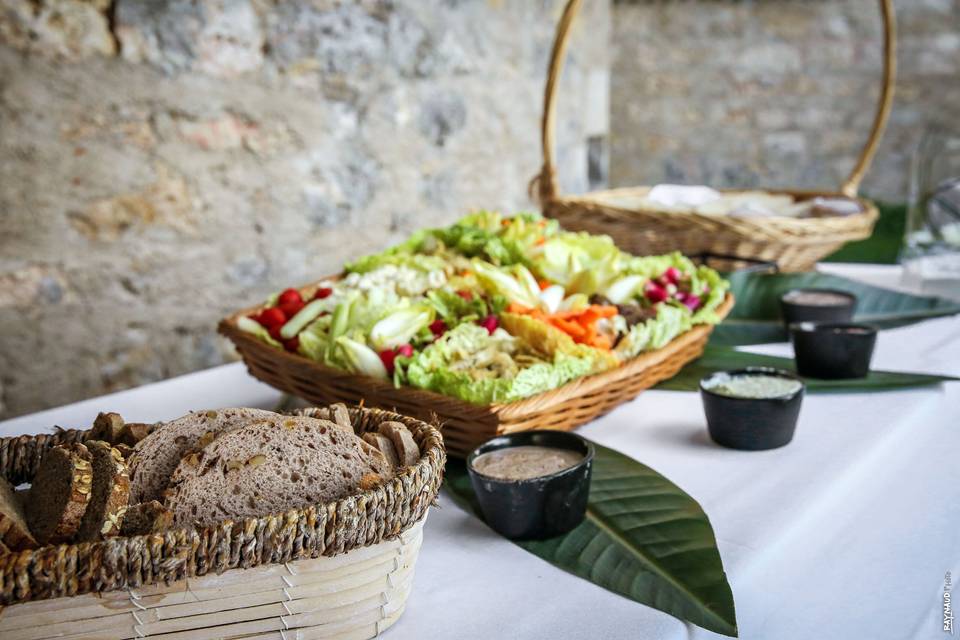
[700, 367, 806, 451]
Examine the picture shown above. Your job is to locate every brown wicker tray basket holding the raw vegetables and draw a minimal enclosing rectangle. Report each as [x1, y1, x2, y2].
[219, 278, 733, 456]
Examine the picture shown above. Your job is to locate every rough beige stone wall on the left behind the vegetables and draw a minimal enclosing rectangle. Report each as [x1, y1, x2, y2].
[0, 0, 609, 417]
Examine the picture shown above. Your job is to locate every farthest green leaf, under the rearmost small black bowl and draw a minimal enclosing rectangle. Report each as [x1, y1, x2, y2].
[710, 271, 960, 346]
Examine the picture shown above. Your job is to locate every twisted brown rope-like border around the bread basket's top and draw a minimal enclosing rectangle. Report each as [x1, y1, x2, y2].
[0, 407, 446, 605]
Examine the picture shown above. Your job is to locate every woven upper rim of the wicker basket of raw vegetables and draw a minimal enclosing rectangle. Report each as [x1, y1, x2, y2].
[218, 286, 735, 418]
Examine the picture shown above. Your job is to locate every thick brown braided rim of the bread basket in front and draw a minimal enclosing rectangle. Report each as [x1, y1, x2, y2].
[0, 408, 446, 605]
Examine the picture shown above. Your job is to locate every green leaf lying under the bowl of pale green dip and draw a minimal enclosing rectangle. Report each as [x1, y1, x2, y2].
[655, 345, 960, 393]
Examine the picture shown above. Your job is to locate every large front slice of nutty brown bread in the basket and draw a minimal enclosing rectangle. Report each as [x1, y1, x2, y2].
[164, 416, 393, 527]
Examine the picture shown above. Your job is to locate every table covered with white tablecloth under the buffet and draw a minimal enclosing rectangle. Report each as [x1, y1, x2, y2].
[0, 265, 960, 640]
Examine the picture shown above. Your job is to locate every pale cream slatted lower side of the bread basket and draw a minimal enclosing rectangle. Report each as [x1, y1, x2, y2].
[0, 520, 424, 640]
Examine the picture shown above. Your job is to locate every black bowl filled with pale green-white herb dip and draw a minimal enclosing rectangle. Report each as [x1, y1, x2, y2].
[700, 367, 804, 451]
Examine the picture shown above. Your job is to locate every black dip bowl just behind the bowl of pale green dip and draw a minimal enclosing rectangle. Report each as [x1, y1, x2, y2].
[790, 322, 877, 380]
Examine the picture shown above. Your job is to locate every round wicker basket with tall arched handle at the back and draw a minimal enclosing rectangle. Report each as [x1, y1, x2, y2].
[531, 0, 896, 271]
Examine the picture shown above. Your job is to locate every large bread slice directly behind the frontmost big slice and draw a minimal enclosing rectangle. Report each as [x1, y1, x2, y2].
[127, 409, 278, 504]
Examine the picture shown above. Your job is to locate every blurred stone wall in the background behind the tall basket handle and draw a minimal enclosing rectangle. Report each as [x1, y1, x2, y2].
[610, 0, 960, 201]
